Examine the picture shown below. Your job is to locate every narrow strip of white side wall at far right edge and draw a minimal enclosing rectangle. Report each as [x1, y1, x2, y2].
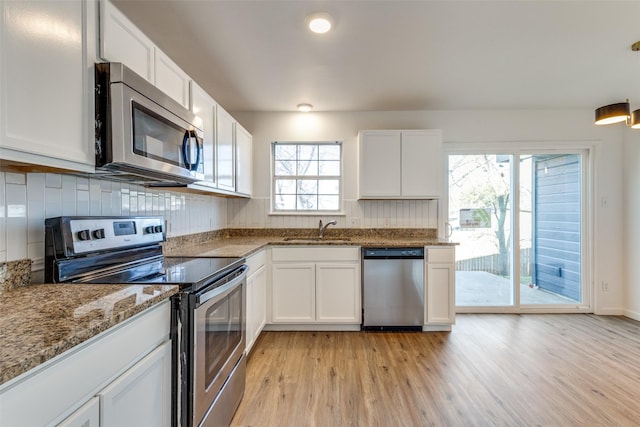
[623, 130, 640, 320]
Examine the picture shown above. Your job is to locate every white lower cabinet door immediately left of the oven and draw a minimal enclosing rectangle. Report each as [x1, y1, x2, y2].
[98, 341, 171, 427]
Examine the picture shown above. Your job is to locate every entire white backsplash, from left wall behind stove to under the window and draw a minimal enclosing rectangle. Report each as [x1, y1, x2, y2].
[0, 172, 438, 270]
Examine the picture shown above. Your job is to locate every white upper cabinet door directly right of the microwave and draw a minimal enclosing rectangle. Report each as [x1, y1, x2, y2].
[190, 81, 216, 187]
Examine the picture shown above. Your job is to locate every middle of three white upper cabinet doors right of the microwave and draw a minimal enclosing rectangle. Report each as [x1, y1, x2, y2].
[216, 105, 236, 191]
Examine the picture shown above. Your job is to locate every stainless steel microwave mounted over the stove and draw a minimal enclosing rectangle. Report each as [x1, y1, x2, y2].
[95, 62, 204, 186]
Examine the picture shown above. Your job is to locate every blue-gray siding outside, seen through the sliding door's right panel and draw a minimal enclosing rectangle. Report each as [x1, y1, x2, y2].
[532, 154, 582, 301]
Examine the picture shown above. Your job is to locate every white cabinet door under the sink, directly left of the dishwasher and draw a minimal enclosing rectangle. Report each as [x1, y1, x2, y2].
[316, 263, 362, 323]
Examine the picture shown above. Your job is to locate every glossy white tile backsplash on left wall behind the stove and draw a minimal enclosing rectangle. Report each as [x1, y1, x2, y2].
[0, 172, 227, 270]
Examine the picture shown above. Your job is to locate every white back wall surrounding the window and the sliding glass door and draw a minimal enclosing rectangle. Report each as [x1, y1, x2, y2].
[235, 110, 624, 314]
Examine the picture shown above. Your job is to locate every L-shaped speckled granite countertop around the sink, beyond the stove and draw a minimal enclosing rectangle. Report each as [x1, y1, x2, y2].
[164, 228, 456, 257]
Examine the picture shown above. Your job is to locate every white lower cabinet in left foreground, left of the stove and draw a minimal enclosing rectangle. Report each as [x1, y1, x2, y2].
[0, 301, 171, 427]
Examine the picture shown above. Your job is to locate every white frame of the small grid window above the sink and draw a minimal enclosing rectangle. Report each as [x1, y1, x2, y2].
[270, 141, 344, 216]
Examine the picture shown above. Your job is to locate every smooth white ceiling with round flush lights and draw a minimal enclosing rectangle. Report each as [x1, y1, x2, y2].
[114, 0, 640, 112]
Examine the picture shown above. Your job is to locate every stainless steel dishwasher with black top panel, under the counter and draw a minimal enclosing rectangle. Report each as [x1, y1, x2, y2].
[362, 247, 424, 331]
